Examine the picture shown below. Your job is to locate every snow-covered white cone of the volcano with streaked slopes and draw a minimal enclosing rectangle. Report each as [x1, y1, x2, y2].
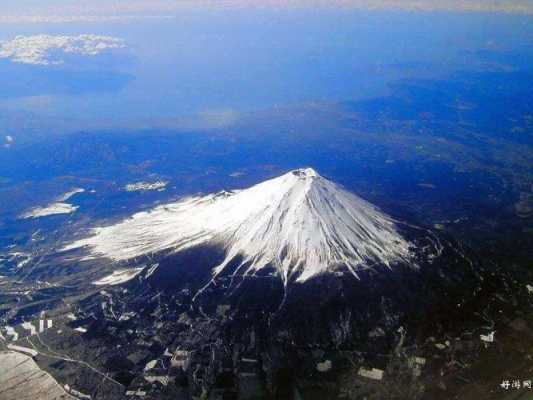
[65, 168, 410, 283]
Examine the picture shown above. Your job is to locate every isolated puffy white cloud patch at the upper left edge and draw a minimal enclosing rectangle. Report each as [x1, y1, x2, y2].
[0, 34, 125, 65]
